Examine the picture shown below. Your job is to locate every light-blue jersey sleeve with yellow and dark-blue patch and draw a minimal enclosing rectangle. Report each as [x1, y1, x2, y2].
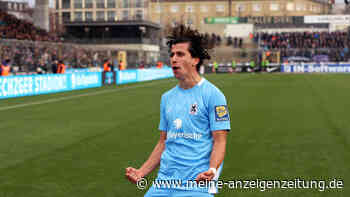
[208, 88, 231, 131]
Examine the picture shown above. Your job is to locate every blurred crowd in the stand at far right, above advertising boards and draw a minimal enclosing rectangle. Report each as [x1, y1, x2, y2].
[254, 32, 350, 62]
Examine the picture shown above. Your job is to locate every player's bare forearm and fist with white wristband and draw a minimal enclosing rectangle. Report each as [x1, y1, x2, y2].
[197, 130, 228, 181]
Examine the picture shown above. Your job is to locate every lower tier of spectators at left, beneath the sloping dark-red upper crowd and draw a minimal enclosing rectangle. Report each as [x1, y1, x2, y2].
[0, 39, 112, 73]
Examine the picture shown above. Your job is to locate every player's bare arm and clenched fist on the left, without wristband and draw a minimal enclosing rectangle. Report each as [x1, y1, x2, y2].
[125, 131, 167, 183]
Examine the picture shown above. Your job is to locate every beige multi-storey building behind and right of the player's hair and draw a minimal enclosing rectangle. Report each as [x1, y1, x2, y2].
[150, 0, 331, 36]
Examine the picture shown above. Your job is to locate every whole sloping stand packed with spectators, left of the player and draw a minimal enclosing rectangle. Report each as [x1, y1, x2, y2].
[0, 11, 126, 74]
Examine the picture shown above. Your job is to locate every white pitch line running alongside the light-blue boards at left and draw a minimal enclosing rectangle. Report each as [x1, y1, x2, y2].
[0, 80, 173, 111]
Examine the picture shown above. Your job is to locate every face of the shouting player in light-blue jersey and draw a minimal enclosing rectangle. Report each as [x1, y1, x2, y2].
[170, 43, 199, 80]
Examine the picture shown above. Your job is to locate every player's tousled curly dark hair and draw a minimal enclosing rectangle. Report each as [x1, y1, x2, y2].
[167, 24, 210, 71]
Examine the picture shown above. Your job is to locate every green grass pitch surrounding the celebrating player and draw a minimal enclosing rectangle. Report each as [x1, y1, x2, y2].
[0, 74, 350, 197]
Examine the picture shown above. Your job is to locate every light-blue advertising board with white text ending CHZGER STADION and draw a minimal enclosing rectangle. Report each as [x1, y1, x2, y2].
[0, 72, 102, 99]
